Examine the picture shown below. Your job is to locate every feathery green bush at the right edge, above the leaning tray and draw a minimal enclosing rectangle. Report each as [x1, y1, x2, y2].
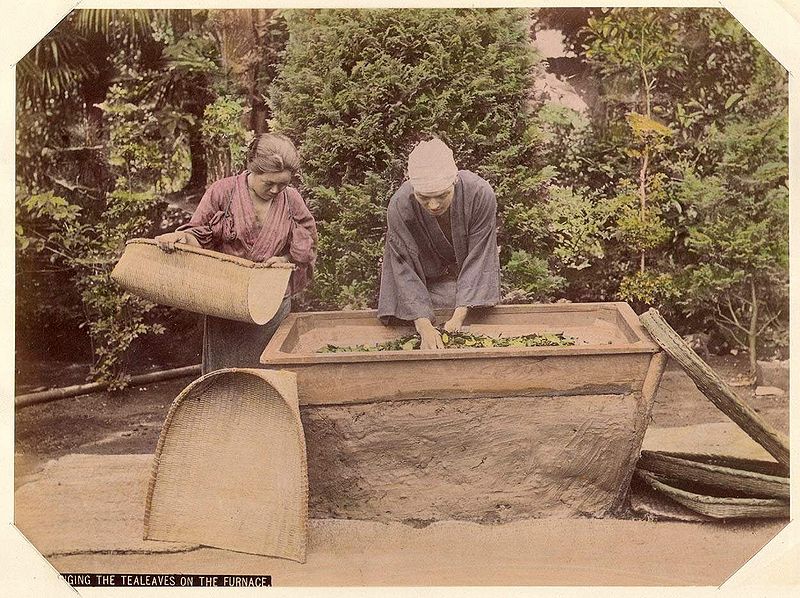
[681, 108, 789, 373]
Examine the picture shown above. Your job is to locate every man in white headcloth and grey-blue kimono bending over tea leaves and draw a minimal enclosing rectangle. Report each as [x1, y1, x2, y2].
[378, 139, 500, 349]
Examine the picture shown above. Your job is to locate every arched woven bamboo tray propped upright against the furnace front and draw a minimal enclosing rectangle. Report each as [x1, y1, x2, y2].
[144, 368, 308, 563]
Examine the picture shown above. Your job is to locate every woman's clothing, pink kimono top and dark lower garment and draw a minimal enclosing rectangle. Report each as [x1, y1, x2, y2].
[178, 171, 317, 374]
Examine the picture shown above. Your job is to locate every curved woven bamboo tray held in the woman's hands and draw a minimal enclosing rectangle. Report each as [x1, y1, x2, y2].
[111, 239, 291, 324]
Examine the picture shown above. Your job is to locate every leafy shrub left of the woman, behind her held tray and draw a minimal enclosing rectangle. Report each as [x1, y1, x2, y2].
[17, 71, 192, 389]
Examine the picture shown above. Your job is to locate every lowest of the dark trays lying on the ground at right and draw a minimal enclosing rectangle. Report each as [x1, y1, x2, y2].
[636, 469, 789, 519]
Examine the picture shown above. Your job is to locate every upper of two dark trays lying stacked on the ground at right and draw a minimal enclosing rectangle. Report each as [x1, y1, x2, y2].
[637, 450, 789, 500]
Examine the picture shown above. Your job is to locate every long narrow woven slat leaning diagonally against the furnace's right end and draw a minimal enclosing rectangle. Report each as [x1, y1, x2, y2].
[640, 308, 789, 468]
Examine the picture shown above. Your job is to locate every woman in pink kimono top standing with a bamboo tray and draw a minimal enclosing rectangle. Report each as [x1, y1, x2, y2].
[156, 133, 317, 374]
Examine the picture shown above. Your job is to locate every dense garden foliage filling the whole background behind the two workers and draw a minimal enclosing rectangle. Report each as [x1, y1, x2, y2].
[16, 8, 788, 385]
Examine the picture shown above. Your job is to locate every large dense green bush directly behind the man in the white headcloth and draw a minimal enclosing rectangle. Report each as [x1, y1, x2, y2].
[270, 9, 554, 308]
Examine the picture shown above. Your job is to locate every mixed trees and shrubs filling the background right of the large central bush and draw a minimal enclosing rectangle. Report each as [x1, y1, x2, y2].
[542, 9, 788, 373]
